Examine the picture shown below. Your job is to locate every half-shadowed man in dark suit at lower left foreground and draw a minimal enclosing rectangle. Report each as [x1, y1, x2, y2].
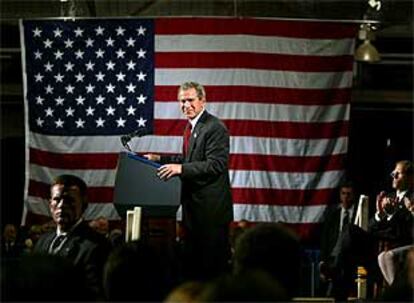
[34, 175, 109, 300]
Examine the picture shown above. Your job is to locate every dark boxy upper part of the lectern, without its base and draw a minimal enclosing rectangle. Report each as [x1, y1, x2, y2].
[114, 152, 181, 218]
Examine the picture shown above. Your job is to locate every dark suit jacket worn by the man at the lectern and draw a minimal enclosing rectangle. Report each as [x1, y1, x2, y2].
[161, 111, 233, 230]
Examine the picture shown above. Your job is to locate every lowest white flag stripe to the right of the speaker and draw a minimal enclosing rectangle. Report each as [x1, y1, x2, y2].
[233, 204, 326, 224]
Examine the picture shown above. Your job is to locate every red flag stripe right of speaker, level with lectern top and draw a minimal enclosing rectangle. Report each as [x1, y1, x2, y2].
[229, 154, 345, 172]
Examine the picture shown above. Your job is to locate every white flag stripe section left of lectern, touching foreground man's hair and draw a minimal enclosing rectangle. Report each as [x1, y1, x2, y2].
[30, 164, 116, 187]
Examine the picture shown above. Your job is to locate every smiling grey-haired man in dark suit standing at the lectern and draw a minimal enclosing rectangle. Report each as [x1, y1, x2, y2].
[145, 82, 233, 279]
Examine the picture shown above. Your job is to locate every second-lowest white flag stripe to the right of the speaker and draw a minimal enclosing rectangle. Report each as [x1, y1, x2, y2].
[229, 170, 344, 190]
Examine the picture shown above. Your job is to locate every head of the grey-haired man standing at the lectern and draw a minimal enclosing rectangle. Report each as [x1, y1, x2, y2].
[178, 82, 206, 120]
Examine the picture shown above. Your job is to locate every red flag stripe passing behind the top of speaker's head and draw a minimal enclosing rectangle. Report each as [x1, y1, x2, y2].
[155, 85, 351, 105]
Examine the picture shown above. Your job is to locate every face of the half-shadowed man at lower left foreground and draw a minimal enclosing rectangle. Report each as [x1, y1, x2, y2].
[49, 184, 83, 231]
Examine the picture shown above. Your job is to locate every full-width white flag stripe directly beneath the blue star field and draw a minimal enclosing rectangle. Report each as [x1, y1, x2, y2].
[30, 133, 348, 157]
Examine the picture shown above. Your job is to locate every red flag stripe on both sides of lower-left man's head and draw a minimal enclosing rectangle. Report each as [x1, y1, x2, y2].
[29, 180, 114, 203]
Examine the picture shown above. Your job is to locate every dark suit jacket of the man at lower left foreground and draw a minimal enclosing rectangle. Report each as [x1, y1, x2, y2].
[34, 222, 109, 298]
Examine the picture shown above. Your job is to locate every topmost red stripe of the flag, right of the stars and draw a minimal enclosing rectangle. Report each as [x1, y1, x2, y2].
[155, 18, 358, 39]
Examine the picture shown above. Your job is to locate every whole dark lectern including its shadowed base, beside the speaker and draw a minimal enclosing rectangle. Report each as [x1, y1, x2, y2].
[114, 152, 181, 255]
